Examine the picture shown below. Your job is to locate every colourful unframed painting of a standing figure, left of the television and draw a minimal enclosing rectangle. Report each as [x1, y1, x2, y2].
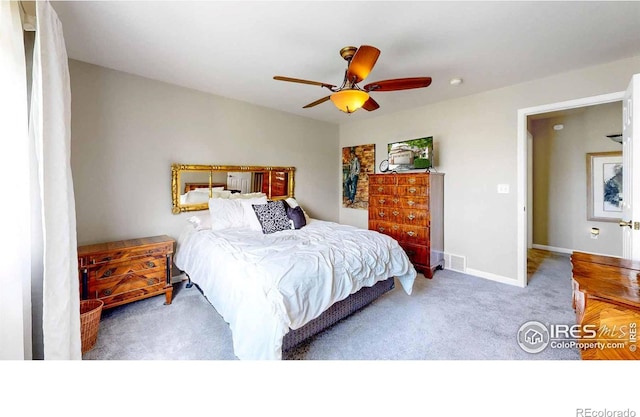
[342, 145, 376, 210]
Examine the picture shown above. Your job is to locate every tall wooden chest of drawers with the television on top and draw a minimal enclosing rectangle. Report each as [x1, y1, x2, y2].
[369, 172, 444, 278]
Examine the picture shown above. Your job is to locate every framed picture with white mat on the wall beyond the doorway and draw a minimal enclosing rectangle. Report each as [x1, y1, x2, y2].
[587, 151, 623, 222]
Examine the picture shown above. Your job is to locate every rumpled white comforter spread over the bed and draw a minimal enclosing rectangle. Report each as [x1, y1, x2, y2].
[175, 219, 416, 359]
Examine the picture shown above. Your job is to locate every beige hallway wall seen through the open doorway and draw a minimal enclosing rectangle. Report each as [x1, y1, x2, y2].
[530, 102, 622, 256]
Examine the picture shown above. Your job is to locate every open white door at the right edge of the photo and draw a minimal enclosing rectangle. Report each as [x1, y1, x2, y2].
[620, 74, 640, 261]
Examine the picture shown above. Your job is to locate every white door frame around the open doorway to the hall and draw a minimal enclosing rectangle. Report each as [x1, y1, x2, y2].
[516, 91, 625, 288]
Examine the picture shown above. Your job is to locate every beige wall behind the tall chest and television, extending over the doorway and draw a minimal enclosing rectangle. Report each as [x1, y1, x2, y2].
[336, 57, 640, 282]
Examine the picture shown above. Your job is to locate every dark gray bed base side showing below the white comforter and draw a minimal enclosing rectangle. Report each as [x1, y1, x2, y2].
[282, 277, 395, 357]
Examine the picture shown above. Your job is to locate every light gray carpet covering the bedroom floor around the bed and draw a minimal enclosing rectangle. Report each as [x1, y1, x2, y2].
[83, 252, 579, 360]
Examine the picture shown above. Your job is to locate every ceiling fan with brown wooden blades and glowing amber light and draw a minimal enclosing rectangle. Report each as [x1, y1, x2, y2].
[273, 45, 431, 113]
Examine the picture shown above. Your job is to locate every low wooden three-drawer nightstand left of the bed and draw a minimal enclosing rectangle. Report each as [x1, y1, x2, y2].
[78, 236, 175, 308]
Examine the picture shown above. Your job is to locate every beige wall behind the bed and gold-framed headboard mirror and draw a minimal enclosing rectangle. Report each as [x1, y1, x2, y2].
[69, 60, 340, 245]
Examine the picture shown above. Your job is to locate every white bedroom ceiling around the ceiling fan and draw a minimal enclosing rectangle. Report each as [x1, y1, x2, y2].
[52, 1, 640, 123]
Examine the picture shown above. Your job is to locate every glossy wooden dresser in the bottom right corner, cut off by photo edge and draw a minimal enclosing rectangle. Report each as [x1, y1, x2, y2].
[571, 252, 640, 360]
